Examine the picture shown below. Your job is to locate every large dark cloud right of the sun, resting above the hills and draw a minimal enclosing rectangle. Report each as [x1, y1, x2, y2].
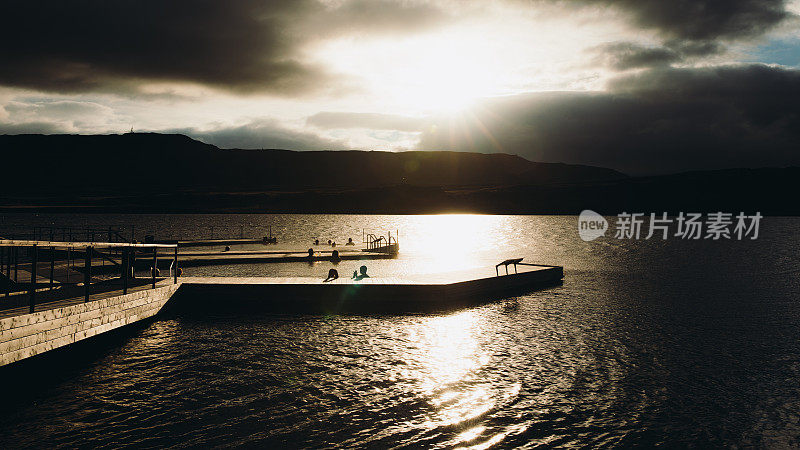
[421, 65, 800, 174]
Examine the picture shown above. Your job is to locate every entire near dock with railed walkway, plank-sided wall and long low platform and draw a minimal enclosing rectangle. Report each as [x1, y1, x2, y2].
[0, 240, 564, 366]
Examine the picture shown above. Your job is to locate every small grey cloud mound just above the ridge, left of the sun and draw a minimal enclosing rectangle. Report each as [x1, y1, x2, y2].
[169, 120, 345, 150]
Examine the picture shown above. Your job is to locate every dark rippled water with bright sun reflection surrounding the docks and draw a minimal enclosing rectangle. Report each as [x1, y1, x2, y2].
[0, 215, 800, 448]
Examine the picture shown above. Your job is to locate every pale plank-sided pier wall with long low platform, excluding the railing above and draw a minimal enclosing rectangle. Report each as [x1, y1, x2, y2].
[0, 265, 564, 366]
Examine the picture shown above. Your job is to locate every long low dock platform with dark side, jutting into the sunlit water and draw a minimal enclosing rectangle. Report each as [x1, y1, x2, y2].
[170, 265, 564, 314]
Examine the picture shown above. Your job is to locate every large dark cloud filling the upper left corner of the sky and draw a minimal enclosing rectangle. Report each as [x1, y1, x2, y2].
[0, 0, 450, 95]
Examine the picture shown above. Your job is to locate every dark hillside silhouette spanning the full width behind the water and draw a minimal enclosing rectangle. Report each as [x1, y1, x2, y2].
[0, 133, 800, 215]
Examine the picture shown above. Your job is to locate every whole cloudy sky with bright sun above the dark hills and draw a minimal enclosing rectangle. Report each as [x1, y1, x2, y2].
[0, 0, 800, 174]
